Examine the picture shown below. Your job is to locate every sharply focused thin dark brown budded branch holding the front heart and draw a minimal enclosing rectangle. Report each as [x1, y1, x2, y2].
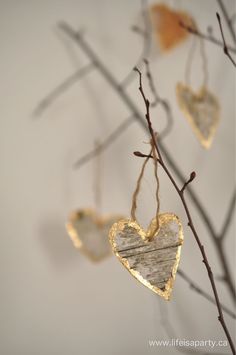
[135, 68, 235, 355]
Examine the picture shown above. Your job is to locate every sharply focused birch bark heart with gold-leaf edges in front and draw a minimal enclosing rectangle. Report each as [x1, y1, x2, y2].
[109, 213, 183, 300]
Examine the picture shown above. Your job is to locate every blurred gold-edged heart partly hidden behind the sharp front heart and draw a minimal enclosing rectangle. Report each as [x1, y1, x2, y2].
[66, 209, 122, 262]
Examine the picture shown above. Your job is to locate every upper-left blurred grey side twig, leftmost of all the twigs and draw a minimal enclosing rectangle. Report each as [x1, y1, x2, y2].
[33, 63, 95, 117]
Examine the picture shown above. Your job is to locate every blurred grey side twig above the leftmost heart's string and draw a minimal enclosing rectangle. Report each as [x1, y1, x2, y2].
[74, 115, 135, 169]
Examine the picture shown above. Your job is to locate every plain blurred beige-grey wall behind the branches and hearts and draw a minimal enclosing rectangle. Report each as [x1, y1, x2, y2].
[0, 0, 235, 355]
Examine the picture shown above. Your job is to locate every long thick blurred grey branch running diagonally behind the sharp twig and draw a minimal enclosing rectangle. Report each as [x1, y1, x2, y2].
[54, 22, 236, 302]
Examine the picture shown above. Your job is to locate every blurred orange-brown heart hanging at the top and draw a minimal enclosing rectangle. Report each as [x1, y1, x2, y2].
[150, 4, 194, 51]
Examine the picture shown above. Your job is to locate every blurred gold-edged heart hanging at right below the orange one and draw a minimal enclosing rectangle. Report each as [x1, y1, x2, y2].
[176, 83, 220, 148]
